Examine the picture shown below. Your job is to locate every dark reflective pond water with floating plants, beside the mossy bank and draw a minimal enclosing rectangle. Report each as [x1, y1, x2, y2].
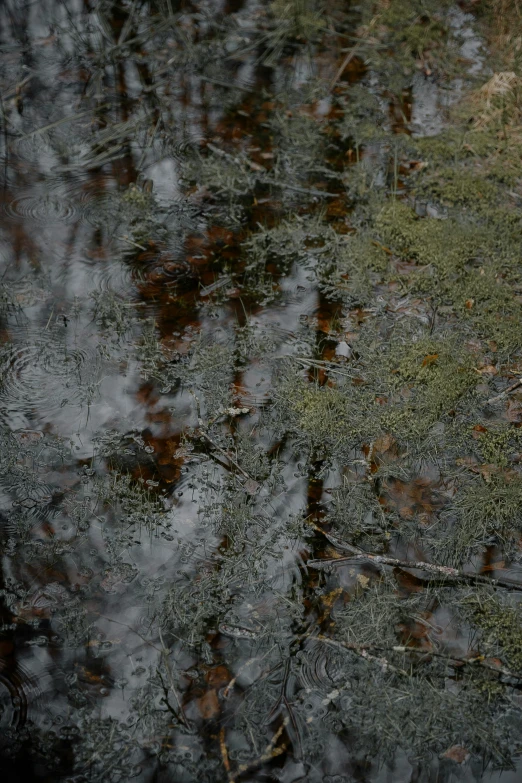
[0, 0, 522, 783]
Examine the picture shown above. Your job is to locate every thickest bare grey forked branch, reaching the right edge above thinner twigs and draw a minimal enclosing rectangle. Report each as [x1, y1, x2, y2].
[307, 531, 522, 590]
